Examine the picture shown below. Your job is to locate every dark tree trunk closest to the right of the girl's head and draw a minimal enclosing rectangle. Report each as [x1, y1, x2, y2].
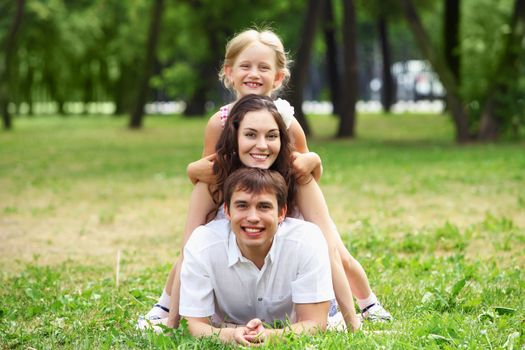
[282, 0, 323, 135]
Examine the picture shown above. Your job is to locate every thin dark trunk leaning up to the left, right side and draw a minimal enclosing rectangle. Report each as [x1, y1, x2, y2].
[400, 0, 471, 142]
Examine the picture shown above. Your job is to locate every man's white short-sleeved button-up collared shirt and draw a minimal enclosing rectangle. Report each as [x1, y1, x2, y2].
[179, 218, 334, 324]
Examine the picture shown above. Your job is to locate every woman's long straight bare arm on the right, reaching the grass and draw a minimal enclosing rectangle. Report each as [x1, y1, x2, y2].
[297, 181, 360, 331]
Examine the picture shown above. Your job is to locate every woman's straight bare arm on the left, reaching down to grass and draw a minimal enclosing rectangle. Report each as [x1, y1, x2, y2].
[168, 182, 215, 327]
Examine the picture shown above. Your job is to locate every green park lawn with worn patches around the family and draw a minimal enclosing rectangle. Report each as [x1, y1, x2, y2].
[0, 115, 525, 349]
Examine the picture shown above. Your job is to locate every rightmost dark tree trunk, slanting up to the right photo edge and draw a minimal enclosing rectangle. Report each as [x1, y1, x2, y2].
[478, 0, 525, 141]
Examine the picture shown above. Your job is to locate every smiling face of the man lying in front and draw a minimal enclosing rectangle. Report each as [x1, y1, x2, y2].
[225, 190, 286, 257]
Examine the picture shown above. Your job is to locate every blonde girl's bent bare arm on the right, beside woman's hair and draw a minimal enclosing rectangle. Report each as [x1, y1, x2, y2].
[289, 119, 323, 182]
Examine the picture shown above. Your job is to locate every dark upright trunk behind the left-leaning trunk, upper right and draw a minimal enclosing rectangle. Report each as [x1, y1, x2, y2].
[443, 0, 461, 85]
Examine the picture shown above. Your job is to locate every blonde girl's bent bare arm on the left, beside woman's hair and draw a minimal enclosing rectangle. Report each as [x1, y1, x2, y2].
[186, 112, 222, 184]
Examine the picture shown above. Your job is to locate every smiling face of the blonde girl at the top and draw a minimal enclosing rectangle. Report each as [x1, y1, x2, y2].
[224, 41, 284, 98]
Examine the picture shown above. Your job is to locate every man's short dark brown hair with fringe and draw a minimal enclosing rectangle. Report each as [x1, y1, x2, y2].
[224, 168, 288, 210]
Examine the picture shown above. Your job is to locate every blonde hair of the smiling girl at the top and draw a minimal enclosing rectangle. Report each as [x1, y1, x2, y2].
[219, 29, 290, 93]
